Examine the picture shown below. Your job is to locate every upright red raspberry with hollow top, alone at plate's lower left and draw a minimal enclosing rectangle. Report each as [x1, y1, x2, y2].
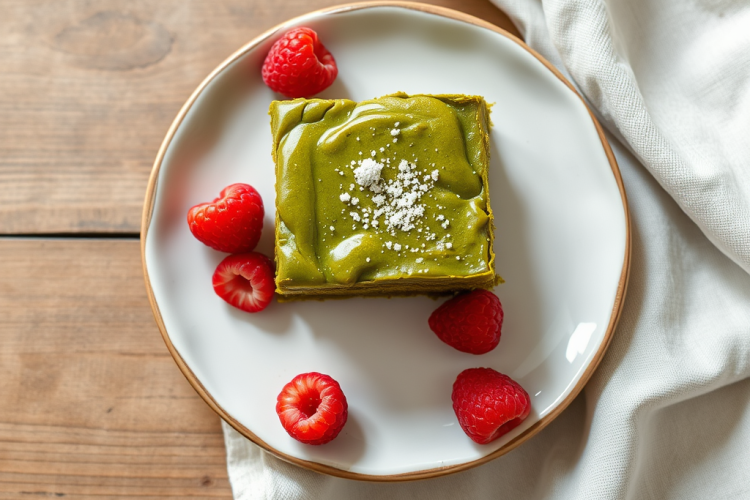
[276, 372, 349, 444]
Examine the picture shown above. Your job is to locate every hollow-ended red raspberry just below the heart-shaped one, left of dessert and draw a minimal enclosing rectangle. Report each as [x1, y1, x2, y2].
[213, 252, 276, 312]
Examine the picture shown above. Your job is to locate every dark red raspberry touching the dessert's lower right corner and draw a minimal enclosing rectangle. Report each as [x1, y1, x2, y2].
[428, 290, 503, 354]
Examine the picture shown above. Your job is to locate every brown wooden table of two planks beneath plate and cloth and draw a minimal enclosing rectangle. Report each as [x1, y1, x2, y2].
[0, 0, 515, 498]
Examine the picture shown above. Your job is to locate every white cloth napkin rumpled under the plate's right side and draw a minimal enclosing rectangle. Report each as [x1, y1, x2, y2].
[224, 0, 750, 500]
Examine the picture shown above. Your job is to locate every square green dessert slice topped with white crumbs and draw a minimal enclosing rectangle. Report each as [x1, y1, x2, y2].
[269, 94, 499, 300]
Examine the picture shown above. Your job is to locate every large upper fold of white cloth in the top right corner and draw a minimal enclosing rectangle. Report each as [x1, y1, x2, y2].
[536, 0, 750, 272]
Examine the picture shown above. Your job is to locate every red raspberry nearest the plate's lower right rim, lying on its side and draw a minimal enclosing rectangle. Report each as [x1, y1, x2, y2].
[451, 368, 531, 444]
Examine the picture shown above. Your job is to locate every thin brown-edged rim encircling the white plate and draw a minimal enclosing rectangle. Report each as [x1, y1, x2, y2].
[140, 1, 631, 482]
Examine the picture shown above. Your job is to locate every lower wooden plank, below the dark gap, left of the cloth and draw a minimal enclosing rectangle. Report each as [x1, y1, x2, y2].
[0, 238, 231, 498]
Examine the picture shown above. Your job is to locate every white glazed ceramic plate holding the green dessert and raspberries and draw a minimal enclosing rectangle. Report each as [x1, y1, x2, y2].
[142, 4, 629, 481]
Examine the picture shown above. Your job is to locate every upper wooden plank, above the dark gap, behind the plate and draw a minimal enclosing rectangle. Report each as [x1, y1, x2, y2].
[0, 0, 512, 234]
